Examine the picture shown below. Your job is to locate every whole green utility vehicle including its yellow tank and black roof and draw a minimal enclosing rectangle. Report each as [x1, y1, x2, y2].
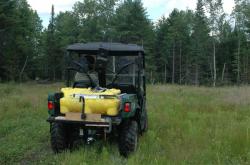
[47, 43, 148, 157]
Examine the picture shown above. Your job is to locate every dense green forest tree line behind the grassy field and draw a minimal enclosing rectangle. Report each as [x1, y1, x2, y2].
[0, 0, 250, 85]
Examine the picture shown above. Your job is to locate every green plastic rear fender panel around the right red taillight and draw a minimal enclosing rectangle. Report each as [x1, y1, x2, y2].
[120, 94, 139, 119]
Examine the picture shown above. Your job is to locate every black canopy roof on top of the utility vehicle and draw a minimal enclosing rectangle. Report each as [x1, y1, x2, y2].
[67, 42, 144, 56]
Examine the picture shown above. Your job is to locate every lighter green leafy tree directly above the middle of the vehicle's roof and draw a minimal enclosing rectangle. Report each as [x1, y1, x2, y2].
[73, 0, 117, 42]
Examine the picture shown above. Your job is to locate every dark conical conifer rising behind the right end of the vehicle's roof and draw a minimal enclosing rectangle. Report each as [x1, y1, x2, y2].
[113, 0, 155, 77]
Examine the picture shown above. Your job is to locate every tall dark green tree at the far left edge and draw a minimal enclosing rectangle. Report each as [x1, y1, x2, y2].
[0, 0, 42, 80]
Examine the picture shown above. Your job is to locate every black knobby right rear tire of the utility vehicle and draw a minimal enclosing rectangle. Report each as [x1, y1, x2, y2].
[118, 120, 138, 157]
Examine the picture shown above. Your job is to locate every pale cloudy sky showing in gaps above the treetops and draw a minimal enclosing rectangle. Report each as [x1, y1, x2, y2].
[28, 0, 234, 27]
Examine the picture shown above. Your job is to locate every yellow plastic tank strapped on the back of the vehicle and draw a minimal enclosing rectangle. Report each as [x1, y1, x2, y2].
[60, 88, 121, 116]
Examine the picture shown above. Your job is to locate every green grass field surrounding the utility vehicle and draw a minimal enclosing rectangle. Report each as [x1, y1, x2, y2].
[0, 84, 250, 165]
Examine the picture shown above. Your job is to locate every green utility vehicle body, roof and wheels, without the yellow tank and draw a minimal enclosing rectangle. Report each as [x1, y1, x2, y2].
[47, 43, 148, 157]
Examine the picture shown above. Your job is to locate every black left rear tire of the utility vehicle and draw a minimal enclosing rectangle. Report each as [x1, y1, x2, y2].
[50, 123, 68, 153]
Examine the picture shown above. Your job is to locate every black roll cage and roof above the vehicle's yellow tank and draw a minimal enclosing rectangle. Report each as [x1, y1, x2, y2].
[66, 42, 146, 98]
